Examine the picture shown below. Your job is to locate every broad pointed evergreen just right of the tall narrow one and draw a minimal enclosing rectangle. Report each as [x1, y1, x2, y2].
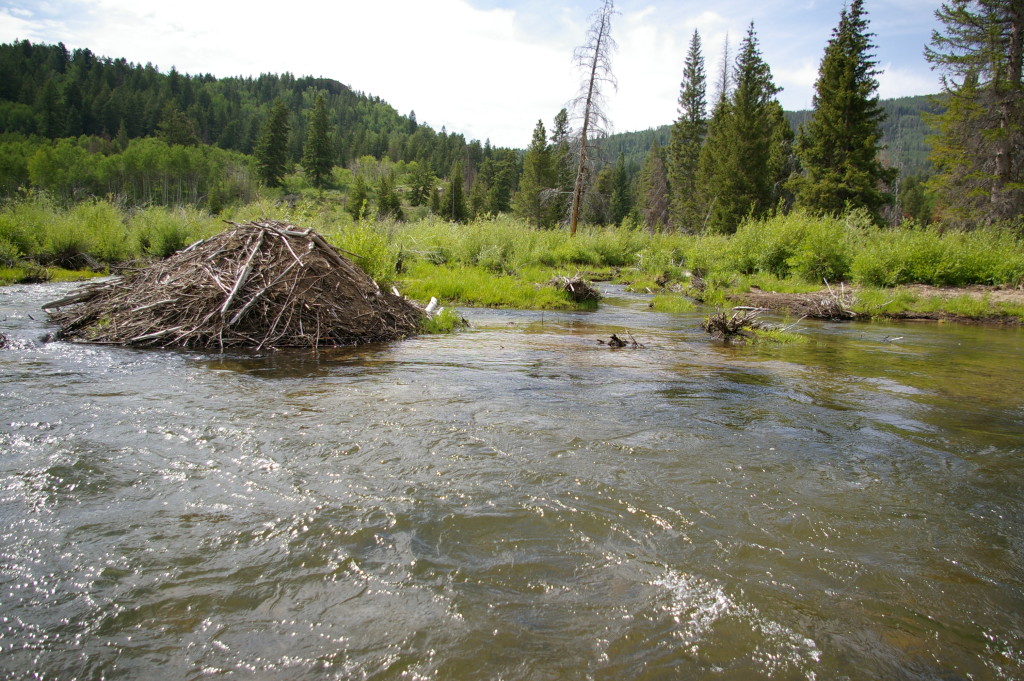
[697, 23, 792, 233]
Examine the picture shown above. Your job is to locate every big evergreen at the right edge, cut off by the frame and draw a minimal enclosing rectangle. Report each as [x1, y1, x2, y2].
[925, 0, 1024, 224]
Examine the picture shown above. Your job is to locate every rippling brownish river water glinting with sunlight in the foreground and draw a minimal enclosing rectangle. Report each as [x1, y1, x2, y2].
[0, 278, 1024, 681]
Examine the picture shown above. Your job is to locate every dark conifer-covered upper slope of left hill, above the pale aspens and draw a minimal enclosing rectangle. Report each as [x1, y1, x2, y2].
[0, 41, 491, 173]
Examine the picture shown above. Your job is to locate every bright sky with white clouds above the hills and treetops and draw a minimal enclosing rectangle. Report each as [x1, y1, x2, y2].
[0, 0, 939, 147]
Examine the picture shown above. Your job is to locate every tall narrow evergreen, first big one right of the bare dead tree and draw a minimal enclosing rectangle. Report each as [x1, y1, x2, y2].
[668, 31, 708, 231]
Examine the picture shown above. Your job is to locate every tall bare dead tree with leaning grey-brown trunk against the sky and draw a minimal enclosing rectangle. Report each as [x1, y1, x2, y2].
[569, 0, 618, 235]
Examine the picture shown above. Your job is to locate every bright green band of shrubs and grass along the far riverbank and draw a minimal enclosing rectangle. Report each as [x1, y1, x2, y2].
[0, 194, 1024, 326]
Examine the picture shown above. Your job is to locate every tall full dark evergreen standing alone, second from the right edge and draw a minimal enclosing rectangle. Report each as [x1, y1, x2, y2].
[791, 0, 895, 222]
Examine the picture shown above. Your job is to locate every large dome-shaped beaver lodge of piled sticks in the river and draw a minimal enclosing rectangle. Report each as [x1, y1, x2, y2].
[43, 221, 426, 349]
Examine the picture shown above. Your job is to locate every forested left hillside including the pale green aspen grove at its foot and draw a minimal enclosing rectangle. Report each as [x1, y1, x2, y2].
[0, 41, 518, 204]
